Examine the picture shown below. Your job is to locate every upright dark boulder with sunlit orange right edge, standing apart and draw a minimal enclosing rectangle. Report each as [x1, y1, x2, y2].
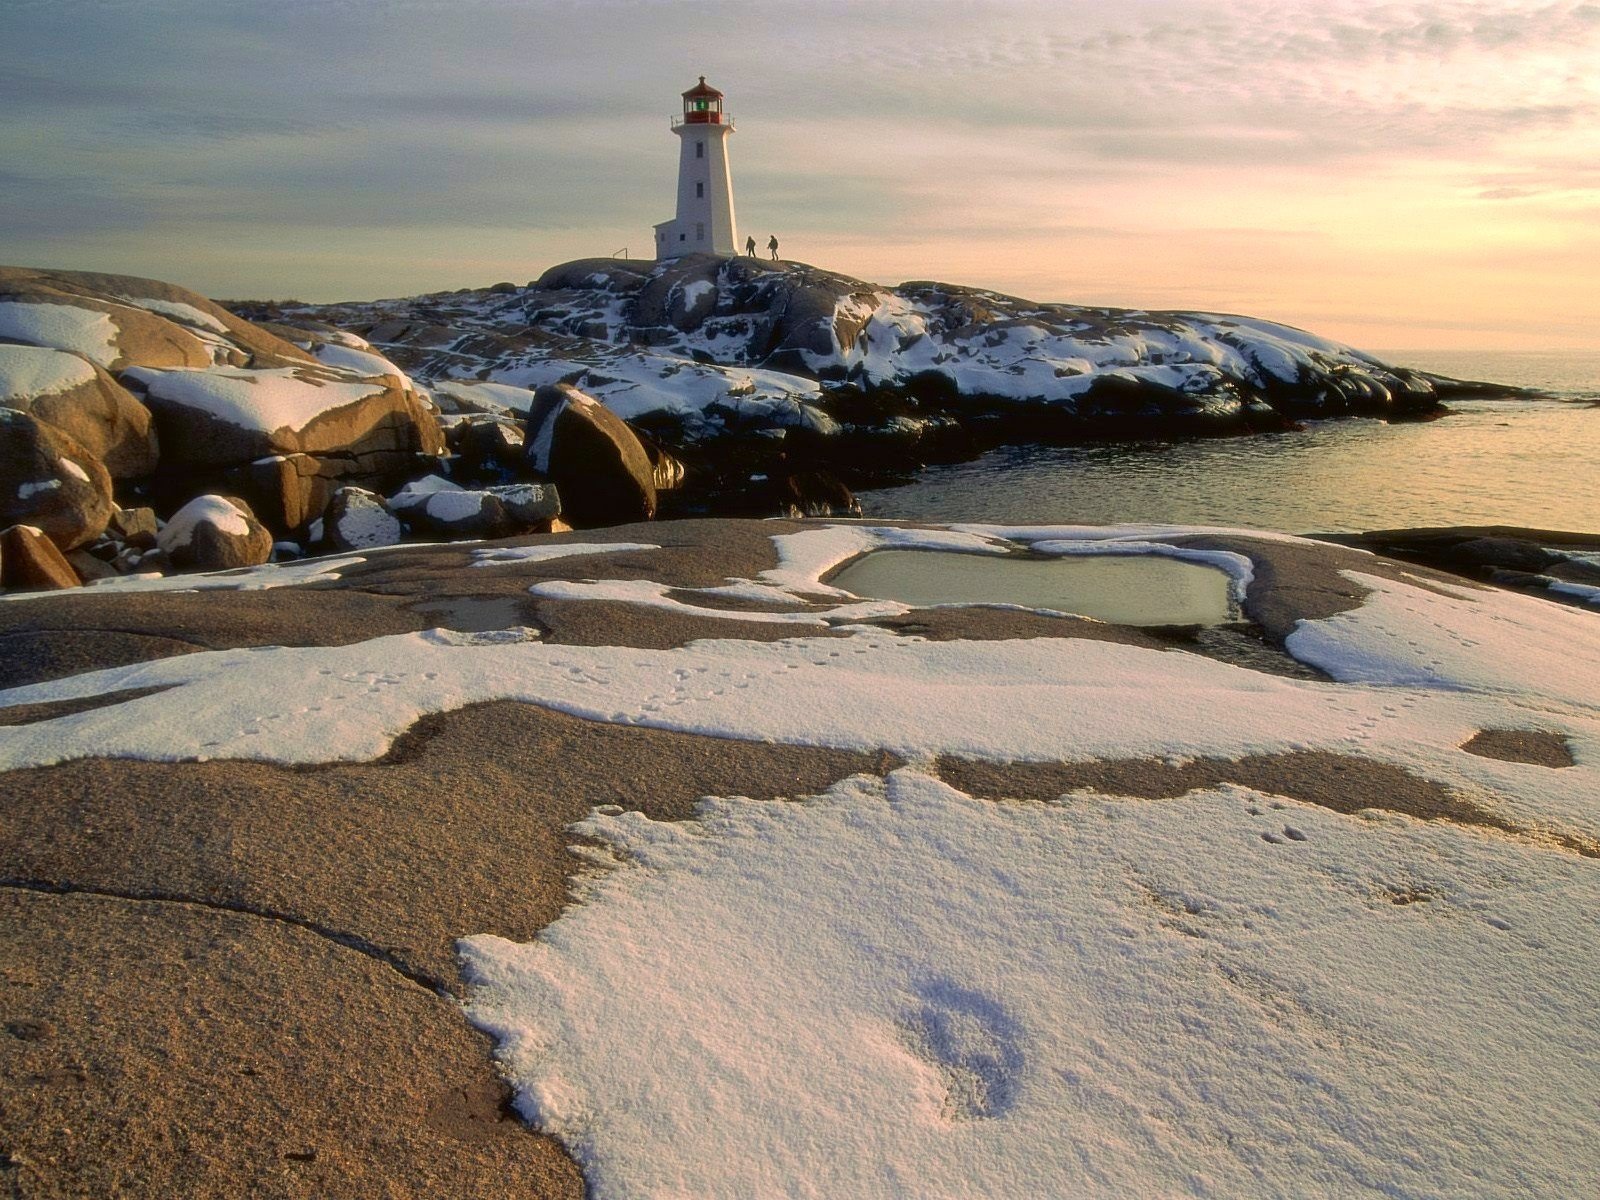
[525, 384, 656, 528]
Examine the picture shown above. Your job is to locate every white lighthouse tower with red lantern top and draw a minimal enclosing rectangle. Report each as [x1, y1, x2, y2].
[656, 75, 739, 258]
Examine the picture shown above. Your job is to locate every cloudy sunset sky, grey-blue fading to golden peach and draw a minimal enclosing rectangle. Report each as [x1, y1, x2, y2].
[0, 0, 1600, 350]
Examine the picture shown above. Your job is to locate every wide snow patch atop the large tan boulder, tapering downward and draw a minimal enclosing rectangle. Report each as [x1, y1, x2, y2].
[123, 366, 384, 434]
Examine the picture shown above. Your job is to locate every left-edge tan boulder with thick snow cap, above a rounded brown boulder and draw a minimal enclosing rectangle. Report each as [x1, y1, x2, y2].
[0, 342, 157, 480]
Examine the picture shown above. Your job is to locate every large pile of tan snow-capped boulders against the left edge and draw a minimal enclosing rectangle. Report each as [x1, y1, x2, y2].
[0, 267, 445, 585]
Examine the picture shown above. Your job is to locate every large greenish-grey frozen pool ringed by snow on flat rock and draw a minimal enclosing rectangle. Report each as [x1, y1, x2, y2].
[829, 550, 1238, 626]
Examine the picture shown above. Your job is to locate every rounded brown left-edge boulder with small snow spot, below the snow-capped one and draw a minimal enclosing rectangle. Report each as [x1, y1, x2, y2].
[0, 408, 117, 550]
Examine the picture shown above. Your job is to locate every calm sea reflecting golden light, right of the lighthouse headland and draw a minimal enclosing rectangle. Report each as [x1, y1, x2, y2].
[861, 350, 1600, 533]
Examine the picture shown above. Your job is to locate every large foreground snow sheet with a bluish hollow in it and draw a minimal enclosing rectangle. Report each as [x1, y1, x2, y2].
[461, 770, 1600, 1200]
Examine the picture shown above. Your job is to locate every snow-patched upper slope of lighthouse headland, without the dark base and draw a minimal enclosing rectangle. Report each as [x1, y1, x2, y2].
[252, 256, 1472, 454]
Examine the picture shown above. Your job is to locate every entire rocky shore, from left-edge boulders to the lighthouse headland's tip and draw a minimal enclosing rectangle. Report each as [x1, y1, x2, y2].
[0, 256, 1536, 601]
